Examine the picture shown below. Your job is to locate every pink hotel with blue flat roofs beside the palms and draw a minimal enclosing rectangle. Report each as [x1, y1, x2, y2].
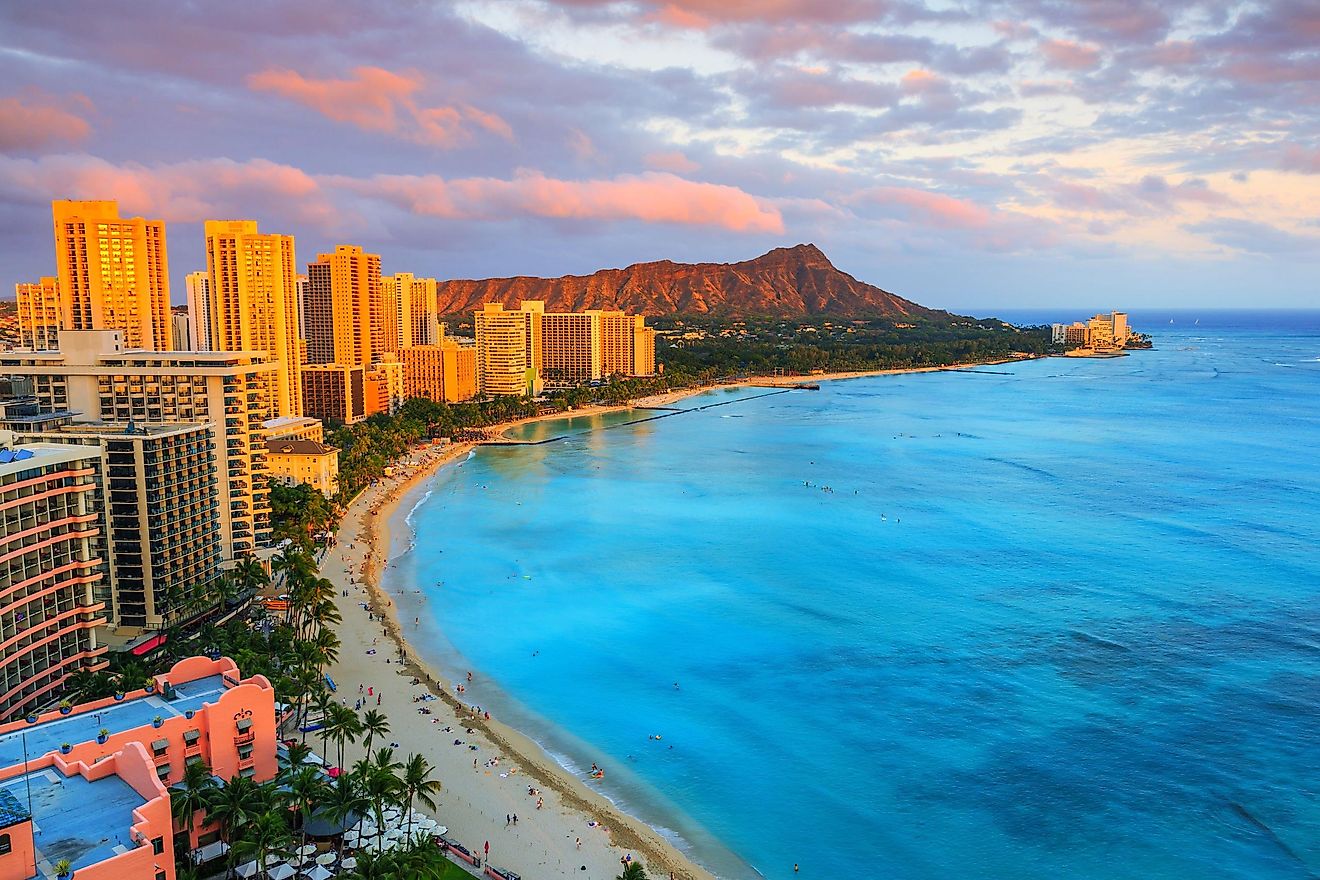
[0, 657, 279, 880]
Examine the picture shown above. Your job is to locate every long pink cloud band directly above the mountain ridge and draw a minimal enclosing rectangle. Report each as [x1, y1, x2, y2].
[343, 172, 784, 232]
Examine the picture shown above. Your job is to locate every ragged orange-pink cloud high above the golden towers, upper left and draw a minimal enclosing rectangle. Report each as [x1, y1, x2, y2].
[247, 66, 513, 148]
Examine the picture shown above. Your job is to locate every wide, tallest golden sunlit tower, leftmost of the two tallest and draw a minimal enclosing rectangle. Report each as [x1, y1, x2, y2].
[51, 199, 170, 351]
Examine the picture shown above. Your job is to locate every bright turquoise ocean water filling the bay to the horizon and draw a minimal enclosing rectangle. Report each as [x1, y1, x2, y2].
[393, 314, 1320, 880]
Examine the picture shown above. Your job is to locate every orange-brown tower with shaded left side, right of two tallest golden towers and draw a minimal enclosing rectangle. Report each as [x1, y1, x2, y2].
[304, 244, 385, 367]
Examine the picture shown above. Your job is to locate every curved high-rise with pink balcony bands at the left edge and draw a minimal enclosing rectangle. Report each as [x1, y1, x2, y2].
[0, 440, 107, 718]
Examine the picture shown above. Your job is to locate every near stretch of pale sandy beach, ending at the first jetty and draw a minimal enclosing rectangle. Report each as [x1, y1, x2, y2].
[322, 443, 711, 880]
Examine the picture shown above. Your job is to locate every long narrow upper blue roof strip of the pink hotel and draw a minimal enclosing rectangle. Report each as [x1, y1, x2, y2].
[0, 676, 226, 770]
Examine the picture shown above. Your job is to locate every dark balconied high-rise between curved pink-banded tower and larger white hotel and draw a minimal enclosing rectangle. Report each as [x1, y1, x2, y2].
[20, 419, 220, 629]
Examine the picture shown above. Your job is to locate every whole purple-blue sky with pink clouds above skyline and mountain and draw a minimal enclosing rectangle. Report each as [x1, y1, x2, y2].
[0, 0, 1320, 311]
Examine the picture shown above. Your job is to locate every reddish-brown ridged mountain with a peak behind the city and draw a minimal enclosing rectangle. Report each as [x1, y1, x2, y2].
[437, 244, 948, 318]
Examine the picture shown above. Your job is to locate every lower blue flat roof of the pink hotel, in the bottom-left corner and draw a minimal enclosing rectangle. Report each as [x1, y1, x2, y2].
[0, 767, 145, 877]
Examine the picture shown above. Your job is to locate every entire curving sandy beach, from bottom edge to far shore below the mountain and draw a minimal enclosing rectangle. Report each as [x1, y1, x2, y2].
[322, 358, 1035, 880]
